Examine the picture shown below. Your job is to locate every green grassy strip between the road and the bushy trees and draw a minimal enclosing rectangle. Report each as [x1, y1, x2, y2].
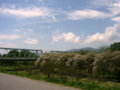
[0, 65, 120, 90]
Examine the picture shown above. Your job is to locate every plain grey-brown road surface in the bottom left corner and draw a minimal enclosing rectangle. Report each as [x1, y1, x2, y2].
[0, 73, 78, 90]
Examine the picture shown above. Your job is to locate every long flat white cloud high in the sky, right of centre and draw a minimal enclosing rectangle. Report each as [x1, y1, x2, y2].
[68, 9, 111, 20]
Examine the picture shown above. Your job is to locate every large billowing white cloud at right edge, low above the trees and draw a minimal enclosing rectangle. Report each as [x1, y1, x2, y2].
[84, 24, 120, 44]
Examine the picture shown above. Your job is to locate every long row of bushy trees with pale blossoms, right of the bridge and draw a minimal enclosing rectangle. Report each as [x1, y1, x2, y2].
[35, 43, 120, 81]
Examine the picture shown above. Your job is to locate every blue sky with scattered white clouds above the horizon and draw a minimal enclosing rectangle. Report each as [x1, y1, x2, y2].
[0, 0, 120, 51]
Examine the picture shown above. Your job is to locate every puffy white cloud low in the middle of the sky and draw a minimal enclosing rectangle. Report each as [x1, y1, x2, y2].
[52, 30, 80, 43]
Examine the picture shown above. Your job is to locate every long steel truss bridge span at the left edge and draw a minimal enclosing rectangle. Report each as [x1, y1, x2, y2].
[0, 47, 43, 61]
